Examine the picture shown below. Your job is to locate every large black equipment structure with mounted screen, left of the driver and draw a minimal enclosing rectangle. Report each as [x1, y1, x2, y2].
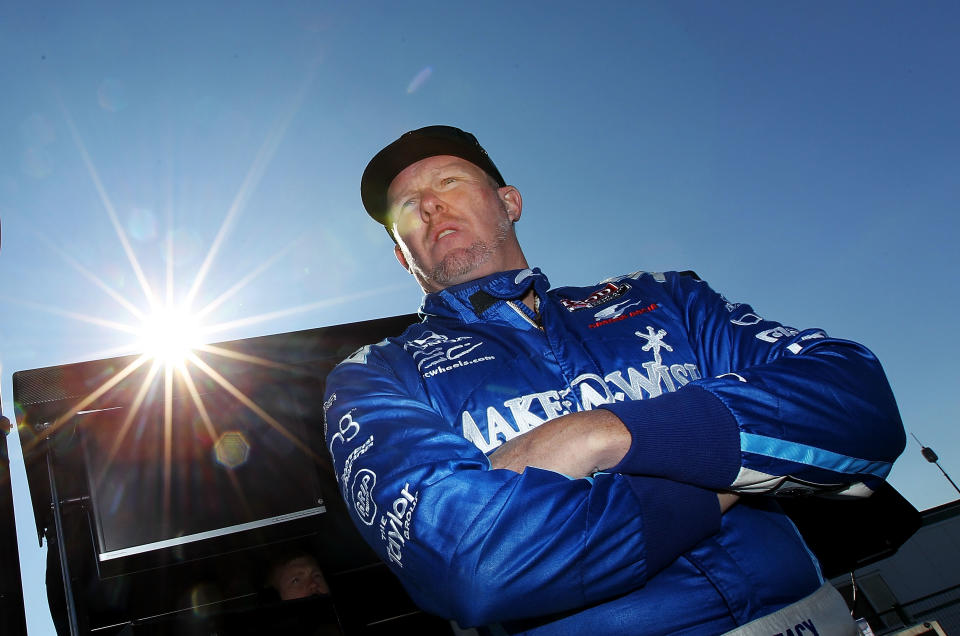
[14, 315, 450, 634]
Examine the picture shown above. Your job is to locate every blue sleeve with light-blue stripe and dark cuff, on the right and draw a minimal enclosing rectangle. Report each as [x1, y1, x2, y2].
[605, 273, 905, 496]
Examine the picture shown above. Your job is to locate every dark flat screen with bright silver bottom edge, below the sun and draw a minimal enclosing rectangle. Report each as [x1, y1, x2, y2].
[77, 368, 326, 561]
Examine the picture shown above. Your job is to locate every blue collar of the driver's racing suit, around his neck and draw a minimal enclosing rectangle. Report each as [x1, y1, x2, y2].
[420, 267, 550, 323]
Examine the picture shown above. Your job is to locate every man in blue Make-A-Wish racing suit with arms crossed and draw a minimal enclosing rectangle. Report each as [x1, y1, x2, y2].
[325, 126, 904, 635]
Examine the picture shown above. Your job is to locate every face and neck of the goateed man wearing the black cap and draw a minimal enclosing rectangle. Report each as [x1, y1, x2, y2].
[387, 155, 527, 293]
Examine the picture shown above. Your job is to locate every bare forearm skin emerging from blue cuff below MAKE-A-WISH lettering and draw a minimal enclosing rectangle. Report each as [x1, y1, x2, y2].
[490, 409, 631, 477]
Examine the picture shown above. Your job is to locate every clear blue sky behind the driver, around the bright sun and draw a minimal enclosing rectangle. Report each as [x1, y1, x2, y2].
[0, 1, 960, 634]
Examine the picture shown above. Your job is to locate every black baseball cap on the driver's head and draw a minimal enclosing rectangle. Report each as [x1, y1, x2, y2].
[360, 126, 507, 226]
